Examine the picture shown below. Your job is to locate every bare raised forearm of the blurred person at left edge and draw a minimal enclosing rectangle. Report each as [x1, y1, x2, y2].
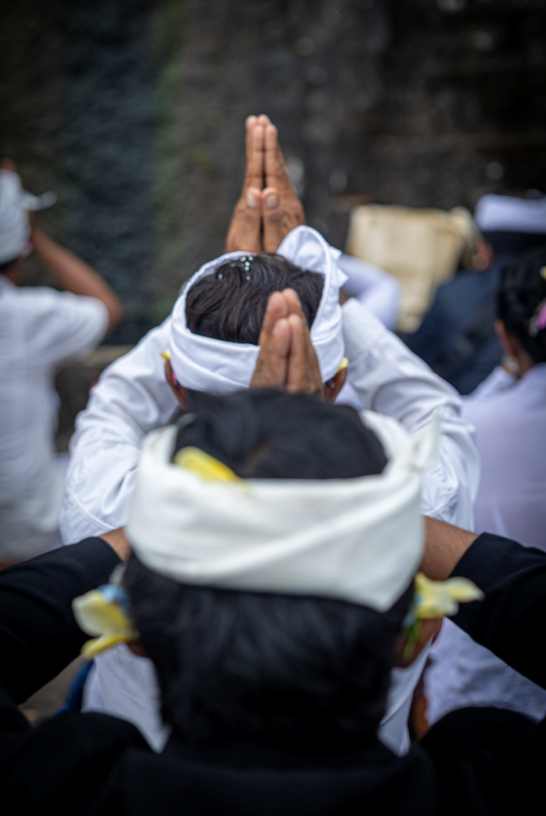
[32, 229, 123, 330]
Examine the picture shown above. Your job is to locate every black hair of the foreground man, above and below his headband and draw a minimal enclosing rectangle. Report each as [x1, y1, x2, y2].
[125, 391, 412, 750]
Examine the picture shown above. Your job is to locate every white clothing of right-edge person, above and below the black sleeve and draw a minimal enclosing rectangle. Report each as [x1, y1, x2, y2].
[427, 363, 546, 721]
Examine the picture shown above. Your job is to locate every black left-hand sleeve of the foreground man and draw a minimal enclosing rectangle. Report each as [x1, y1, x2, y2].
[0, 538, 120, 703]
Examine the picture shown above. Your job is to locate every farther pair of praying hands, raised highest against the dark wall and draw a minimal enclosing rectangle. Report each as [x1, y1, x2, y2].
[226, 114, 305, 253]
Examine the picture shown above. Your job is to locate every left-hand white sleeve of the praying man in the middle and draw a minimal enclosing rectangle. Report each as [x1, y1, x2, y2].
[60, 321, 178, 544]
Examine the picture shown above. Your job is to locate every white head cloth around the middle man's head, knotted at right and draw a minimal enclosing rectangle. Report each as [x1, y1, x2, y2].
[170, 227, 347, 394]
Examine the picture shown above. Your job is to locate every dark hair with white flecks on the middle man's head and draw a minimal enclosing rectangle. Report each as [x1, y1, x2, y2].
[186, 254, 324, 345]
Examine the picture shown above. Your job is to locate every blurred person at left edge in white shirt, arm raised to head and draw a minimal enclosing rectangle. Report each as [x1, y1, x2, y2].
[0, 160, 122, 566]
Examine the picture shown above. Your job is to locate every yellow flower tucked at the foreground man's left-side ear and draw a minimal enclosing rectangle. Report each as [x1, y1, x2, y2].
[72, 584, 138, 660]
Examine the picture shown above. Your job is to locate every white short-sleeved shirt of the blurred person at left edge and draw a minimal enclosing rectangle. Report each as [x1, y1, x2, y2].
[0, 275, 108, 561]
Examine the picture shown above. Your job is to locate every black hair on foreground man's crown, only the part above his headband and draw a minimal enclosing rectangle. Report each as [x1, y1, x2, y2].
[171, 389, 387, 479]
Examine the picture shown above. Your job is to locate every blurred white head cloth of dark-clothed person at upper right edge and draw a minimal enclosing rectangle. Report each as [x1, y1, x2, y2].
[474, 193, 546, 234]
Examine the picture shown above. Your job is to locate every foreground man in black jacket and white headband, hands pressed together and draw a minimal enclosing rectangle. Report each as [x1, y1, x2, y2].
[0, 386, 546, 816]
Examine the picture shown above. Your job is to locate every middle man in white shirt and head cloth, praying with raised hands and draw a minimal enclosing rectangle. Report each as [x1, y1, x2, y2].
[61, 116, 477, 751]
